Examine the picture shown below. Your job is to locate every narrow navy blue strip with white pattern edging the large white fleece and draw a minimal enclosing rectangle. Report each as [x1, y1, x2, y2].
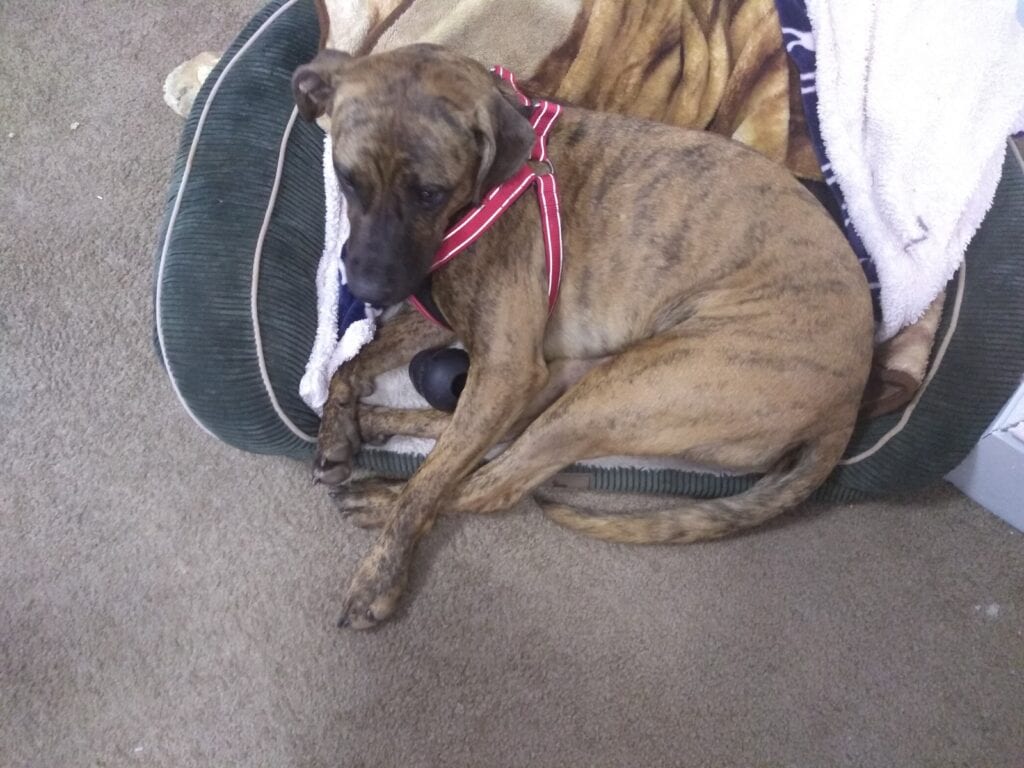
[775, 0, 882, 321]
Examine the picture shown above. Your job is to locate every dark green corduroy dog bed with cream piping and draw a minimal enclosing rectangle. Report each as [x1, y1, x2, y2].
[155, 0, 1024, 500]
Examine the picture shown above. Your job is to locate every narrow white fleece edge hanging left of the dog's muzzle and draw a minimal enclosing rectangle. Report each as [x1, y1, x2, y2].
[299, 133, 380, 415]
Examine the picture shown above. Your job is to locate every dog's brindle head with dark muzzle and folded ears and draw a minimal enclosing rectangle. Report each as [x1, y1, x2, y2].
[292, 44, 535, 305]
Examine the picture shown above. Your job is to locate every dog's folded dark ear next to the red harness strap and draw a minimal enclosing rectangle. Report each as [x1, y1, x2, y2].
[473, 90, 537, 205]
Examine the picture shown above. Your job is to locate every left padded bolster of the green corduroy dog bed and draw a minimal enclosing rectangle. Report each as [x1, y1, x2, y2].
[155, 0, 324, 457]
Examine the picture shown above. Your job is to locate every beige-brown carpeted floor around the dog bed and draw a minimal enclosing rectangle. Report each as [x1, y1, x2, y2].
[0, 0, 1024, 768]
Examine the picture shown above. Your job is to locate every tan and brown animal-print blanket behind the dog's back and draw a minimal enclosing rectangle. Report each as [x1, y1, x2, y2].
[317, 0, 821, 179]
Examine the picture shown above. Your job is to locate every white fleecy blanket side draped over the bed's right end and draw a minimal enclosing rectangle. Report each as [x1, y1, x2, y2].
[807, 0, 1024, 339]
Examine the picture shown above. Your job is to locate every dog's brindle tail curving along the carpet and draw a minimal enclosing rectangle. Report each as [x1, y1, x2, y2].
[539, 430, 850, 544]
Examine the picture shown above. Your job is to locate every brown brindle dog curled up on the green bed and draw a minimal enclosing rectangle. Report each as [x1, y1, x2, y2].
[293, 45, 872, 629]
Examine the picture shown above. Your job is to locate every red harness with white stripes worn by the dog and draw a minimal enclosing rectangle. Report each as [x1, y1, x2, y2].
[409, 67, 562, 326]
